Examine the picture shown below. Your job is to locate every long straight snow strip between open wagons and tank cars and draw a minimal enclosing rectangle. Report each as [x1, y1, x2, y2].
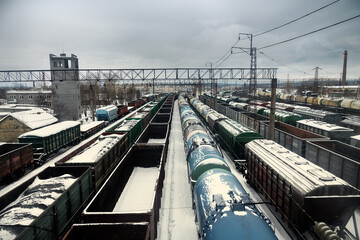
[157, 101, 198, 240]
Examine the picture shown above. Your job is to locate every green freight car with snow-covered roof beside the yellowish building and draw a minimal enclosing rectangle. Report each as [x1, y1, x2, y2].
[18, 121, 81, 163]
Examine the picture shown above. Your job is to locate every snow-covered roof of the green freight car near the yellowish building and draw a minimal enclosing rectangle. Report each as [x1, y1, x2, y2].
[19, 121, 80, 138]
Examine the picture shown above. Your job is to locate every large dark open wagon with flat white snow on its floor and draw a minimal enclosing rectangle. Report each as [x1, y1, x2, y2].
[82, 144, 166, 239]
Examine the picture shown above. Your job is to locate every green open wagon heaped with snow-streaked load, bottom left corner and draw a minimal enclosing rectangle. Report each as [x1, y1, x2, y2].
[0, 167, 94, 240]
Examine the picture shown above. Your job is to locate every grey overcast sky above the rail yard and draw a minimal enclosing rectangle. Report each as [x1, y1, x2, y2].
[0, 0, 360, 79]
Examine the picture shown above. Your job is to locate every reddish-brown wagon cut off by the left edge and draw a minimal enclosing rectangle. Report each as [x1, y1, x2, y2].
[0, 143, 34, 182]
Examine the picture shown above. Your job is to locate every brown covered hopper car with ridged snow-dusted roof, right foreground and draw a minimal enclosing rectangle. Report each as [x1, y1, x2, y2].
[246, 140, 360, 232]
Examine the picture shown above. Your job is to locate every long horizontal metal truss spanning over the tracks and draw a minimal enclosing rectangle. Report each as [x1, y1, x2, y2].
[0, 68, 277, 84]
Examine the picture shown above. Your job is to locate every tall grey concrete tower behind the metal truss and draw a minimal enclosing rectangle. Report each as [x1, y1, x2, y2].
[50, 53, 81, 121]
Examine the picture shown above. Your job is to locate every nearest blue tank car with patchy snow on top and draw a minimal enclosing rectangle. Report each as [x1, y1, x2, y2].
[194, 169, 277, 240]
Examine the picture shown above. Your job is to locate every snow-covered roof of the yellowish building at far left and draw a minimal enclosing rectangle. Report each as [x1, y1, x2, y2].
[5, 108, 58, 129]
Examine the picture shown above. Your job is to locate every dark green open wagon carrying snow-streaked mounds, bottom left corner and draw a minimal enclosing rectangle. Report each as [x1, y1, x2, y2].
[0, 167, 94, 240]
